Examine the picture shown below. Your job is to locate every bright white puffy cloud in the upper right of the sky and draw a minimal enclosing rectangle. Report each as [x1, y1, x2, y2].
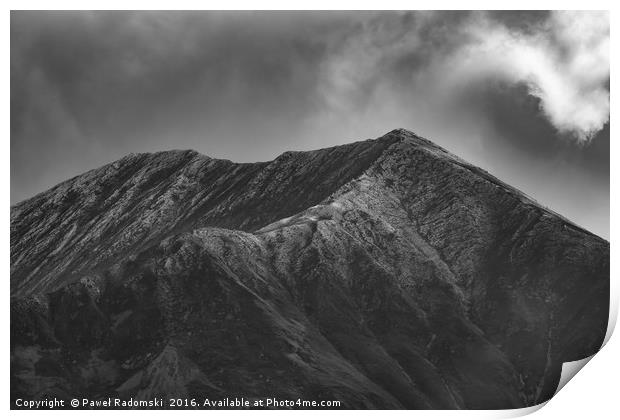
[435, 11, 609, 143]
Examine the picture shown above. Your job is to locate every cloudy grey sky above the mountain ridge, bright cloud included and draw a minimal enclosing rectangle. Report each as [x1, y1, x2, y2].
[10, 11, 610, 239]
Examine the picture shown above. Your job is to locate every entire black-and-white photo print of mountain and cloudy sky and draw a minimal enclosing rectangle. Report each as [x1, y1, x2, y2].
[10, 12, 610, 409]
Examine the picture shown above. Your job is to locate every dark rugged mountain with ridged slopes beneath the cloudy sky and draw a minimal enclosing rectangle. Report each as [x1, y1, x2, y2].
[11, 130, 609, 409]
